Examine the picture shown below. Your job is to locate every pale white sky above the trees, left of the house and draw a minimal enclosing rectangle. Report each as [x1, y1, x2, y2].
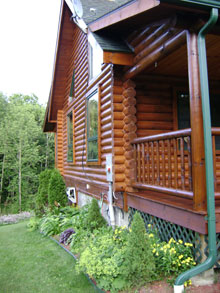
[0, 0, 61, 105]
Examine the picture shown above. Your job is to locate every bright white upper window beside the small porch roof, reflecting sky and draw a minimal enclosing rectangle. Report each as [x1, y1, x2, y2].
[88, 33, 103, 80]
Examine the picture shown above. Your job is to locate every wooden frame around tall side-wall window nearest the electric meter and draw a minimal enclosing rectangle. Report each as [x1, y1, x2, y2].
[86, 86, 101, 165]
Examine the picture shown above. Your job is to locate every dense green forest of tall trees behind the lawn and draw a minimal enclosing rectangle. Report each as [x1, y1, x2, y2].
[0, 92, 54, 214]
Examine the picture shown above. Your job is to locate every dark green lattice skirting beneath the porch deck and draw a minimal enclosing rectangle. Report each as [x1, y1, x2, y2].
[128, 208, 202, 263]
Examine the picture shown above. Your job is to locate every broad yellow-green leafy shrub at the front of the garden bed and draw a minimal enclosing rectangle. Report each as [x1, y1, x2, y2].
[77, 227, 127, 291]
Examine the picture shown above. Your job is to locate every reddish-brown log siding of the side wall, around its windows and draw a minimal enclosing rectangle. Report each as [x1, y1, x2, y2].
[55, 27, 113, 197]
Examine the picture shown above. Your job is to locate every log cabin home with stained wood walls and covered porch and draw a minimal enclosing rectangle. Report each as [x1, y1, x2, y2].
[44, 0, 220, 260]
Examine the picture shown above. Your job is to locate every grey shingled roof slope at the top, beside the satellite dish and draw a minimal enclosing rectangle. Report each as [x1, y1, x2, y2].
[81, 0, 134, 24]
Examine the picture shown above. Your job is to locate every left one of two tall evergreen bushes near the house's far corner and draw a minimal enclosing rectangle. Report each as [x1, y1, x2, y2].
[36, 169, 53, 213]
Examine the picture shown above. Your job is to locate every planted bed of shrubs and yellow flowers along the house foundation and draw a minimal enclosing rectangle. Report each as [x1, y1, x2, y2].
[27, 200, 195, 292]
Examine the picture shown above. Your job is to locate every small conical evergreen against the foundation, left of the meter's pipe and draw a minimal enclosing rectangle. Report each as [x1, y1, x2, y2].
[85, 198, 107, 231]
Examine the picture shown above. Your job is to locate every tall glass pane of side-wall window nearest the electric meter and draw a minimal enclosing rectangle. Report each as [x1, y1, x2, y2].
[87, 90, 99, 162]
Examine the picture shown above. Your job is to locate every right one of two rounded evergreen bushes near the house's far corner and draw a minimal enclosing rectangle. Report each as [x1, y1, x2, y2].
[48, 169, 67, 209]
